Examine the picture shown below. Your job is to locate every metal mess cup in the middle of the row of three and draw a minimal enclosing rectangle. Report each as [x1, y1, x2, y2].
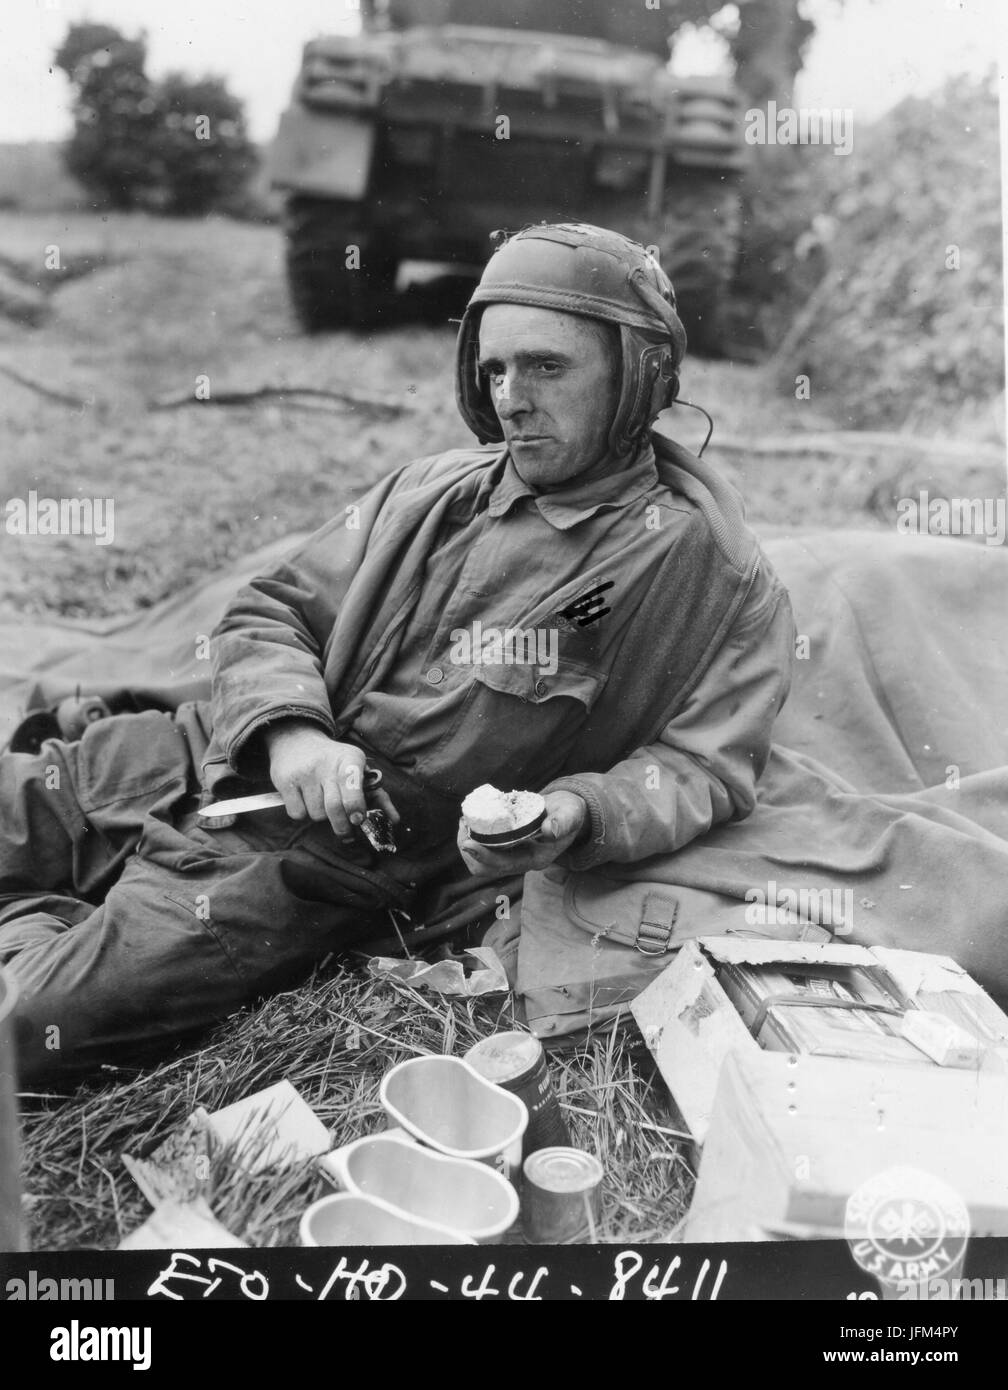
[320, 1134, 519, 1245]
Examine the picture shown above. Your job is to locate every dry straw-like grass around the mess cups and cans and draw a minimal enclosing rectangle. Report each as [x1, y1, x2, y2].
[22, 970, 691, 1250]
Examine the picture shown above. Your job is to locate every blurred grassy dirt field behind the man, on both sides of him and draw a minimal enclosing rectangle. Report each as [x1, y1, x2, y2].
[0, 213, 1004, 616]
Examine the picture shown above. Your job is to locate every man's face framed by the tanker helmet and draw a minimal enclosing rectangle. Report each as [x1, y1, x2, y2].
[480, 304, 620, 492]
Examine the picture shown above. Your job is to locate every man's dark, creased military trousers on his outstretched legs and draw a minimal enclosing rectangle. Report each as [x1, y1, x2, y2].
[0, 705, 460, 1088]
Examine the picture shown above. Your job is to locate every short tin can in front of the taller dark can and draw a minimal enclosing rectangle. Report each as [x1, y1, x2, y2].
[521, 1148, 602, 1245]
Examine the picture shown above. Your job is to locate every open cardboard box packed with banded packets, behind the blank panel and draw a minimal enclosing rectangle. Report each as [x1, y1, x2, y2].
[631, 937, 1008, 1144]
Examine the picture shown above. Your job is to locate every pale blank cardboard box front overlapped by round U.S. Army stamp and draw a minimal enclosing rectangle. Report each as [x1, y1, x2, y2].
[678, 1048, 1008, 1245]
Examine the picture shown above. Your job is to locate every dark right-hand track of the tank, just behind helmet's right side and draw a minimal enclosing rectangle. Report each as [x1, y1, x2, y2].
[658, 177, 742, 356]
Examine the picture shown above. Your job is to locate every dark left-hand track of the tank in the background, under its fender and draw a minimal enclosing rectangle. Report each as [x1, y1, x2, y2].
[284, 197, 396, 334]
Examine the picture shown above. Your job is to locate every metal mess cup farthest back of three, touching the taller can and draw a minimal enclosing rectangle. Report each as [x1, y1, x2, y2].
[378, 1056, 528, 1182]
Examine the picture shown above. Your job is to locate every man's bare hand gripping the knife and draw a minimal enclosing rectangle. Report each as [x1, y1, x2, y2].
[264, 720, 399, 840]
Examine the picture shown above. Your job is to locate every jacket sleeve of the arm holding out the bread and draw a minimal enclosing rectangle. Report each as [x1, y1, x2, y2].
[544, 569, 795, 869]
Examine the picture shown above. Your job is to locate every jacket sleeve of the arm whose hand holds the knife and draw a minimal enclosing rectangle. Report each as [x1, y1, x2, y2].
[210, 459, 428, 777]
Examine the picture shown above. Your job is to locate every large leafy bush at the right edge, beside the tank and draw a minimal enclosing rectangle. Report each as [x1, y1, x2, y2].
[735, 70, 1004, 428]
